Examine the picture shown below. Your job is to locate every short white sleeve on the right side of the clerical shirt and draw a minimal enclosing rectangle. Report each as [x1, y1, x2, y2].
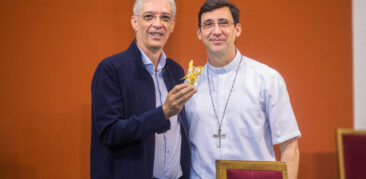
[266, 71, 301, 144]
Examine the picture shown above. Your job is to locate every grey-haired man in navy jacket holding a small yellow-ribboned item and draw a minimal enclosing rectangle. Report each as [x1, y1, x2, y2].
[90, 0, 196, 179]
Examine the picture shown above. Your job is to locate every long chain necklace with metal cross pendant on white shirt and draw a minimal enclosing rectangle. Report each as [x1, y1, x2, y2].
[207, 56, 243, 148]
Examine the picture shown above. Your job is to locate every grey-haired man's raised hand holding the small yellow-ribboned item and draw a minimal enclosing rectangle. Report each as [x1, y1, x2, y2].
[162, 84, 197, 119]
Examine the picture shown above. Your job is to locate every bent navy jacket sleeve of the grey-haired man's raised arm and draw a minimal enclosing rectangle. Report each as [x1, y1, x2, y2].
[92, 60, 170, 147]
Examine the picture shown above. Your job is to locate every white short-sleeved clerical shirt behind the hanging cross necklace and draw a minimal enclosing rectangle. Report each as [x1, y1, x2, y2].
[186, 50, 301, 179]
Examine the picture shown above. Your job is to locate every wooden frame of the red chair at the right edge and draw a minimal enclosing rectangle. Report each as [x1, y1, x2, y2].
[337, 128, 366, 179]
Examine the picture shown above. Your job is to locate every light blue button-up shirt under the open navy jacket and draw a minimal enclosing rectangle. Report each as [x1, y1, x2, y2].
[140, 45, 183, 179]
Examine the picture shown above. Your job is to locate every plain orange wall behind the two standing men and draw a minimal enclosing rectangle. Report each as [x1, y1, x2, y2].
[0, 0, 353, 179]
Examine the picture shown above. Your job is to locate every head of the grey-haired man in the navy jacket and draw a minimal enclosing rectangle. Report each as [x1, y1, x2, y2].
[131, 0, 175, 51]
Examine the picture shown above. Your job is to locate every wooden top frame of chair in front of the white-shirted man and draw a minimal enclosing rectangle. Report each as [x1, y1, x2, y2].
[216, 160, 287, 179]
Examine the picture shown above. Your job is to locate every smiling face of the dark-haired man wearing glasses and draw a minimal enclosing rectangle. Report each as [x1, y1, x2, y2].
[197, 7, 241, 56]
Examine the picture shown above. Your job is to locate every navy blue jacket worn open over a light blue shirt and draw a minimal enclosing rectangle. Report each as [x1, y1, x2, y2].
[90, 41, 191, 179]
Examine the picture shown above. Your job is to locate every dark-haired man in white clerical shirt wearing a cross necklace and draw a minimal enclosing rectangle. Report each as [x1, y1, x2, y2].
[186, 0, 301, 179]
